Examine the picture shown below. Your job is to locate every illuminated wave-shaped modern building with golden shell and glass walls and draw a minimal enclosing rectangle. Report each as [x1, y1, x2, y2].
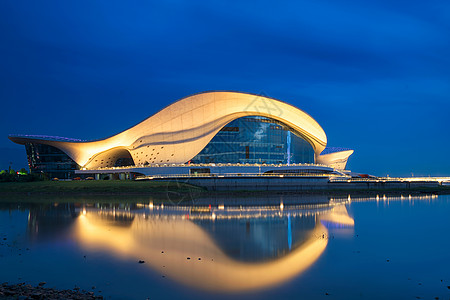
[9, 91, 353, 178]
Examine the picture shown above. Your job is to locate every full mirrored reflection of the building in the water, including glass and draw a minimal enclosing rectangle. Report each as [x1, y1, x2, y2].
[25, 199, 354, 292]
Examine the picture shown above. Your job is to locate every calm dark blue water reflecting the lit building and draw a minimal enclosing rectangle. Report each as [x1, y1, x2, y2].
[0, 195, 450, 299]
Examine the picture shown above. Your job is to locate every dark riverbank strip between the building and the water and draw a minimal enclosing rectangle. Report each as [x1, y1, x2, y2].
[0, 180, 450, 202]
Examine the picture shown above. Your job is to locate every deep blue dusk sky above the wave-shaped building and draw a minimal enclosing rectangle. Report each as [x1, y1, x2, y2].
[0, 0, 450, 176]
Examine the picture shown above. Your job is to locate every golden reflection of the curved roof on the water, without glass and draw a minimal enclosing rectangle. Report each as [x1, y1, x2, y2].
[73, 203, 354, 292]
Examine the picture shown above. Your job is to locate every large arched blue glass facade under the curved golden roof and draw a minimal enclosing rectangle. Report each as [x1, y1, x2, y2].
[191, 116, 314, 164]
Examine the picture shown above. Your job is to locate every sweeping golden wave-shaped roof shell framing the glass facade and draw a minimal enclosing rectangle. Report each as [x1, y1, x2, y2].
[9, 92, 327, 168]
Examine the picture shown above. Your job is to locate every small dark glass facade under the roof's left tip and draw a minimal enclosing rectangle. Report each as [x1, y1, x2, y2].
[25, 143, 80, 179]
